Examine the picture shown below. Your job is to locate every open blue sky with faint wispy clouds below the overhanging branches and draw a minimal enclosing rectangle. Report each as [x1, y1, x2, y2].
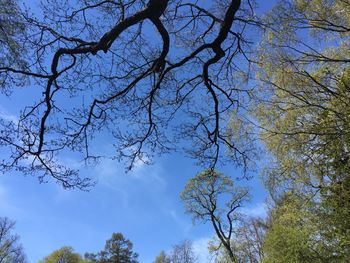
[0, 1, 271, 263]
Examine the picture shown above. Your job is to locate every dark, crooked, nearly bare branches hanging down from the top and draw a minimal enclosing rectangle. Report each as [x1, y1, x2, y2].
[0, 0, 256, 188]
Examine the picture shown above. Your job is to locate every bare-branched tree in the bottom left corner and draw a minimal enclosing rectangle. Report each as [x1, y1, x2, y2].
[0, 217, 27, 263]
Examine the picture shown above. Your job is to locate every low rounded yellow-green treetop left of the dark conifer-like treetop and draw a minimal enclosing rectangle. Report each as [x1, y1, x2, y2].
[39, 247, 87, 263]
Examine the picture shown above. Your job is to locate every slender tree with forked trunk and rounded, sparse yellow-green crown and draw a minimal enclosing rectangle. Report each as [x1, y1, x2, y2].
[181, 170, 248, 262]
